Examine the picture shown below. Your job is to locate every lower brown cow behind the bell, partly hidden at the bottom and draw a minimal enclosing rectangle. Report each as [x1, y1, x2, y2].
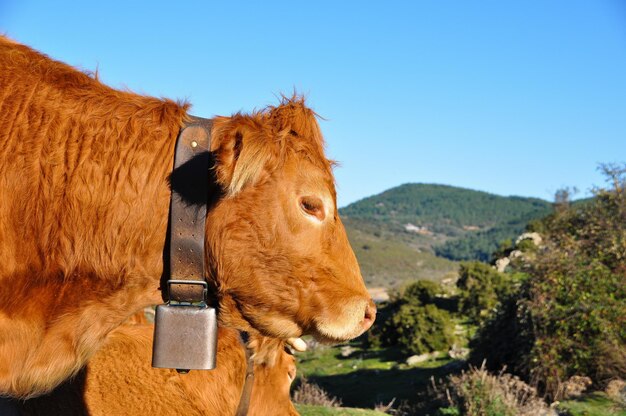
[15, 325, 298, 416]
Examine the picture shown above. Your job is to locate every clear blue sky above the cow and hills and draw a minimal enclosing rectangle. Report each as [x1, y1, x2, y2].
[0, 0, 626, 206]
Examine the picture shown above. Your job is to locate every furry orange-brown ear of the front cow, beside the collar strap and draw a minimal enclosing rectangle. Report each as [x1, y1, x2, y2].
[211, 115, 271, 196]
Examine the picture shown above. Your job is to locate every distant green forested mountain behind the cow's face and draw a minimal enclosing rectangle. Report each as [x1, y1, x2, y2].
[340, 183, 552, 287]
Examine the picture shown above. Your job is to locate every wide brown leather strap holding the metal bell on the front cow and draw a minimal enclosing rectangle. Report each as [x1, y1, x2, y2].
[163, 117, 212, 303]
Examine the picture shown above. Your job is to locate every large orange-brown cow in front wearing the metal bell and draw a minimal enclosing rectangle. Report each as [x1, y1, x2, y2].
[0, 37, 375, 398]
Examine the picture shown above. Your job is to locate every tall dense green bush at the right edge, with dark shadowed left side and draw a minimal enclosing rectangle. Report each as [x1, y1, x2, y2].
[472, 168, 626, 400]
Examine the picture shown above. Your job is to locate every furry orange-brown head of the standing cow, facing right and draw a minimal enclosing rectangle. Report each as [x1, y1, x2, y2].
[207, 99, 376, 342]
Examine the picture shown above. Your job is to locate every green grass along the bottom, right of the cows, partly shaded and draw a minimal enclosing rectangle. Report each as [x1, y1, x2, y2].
[298, 343, 626, 416]
